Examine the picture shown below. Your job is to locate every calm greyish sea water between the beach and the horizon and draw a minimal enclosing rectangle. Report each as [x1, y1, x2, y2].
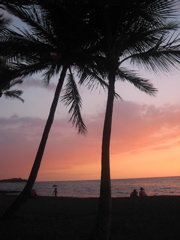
[0, 177, 180, 198]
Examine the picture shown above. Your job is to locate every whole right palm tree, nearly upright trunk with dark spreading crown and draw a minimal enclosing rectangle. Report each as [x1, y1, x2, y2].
[1, 0, 180, 240]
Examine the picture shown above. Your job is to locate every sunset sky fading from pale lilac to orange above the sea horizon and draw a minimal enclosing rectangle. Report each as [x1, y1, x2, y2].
[0, 3, 180, 181]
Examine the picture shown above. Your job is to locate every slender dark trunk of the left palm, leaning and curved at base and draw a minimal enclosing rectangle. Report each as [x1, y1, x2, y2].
[0, 67, 67, 220]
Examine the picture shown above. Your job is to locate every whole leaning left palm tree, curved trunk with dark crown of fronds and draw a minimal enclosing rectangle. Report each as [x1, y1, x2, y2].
[0, 1, 106, 220]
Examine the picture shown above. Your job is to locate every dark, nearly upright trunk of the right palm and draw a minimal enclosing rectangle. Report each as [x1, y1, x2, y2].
[89, 74, 115, 240]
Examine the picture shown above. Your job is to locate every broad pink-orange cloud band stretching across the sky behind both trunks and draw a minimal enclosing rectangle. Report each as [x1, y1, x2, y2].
[0, 101, 180, 178]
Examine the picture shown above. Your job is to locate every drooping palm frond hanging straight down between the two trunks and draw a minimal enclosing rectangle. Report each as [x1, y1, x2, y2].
[61, 68, 87, 134]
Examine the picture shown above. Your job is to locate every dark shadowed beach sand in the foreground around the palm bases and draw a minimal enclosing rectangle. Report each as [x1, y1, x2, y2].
[0, 195, 180, 240]
